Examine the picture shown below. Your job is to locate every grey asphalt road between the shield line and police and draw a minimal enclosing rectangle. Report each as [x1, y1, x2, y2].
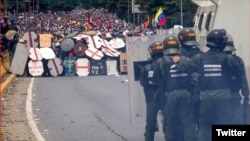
[31, 75, 164, 141]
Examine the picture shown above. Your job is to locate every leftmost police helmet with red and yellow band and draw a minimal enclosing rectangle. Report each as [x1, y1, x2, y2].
[148, 41, 163, 57]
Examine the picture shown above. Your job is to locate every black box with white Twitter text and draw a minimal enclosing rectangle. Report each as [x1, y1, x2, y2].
[212, 125, 250, 141]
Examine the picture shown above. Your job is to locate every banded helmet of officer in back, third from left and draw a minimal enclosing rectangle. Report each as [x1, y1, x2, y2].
[178, 28, 199, 46]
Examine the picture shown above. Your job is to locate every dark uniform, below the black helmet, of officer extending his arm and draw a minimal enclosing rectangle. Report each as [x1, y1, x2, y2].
[174, 49, 240, 141]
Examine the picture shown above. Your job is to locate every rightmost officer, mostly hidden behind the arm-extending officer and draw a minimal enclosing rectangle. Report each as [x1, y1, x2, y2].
[224, 33, 249, 124]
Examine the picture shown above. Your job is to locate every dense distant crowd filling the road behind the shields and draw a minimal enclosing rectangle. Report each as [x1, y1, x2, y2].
[1, 7, 153, 39]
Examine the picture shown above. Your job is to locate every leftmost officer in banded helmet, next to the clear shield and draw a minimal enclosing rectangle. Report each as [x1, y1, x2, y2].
[140, 41, 163, 141]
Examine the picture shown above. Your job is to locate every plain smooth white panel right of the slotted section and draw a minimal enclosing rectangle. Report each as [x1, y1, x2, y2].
[214, 0, 250, 87]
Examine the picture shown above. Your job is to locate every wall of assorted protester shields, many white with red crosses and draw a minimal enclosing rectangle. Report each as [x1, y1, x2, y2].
[10, 32, 126, 77]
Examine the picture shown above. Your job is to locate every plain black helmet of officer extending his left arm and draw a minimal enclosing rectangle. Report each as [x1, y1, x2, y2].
[206, 29, 227, 50]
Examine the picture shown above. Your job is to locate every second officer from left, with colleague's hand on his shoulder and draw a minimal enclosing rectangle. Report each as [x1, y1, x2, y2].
[152, 35, 195, 141]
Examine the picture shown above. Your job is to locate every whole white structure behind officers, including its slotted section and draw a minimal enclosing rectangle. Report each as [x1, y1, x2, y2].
[192, 0, 250, 83]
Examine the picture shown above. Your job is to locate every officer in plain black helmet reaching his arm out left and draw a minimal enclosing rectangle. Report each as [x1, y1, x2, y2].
[172, 29, 241, 141]
